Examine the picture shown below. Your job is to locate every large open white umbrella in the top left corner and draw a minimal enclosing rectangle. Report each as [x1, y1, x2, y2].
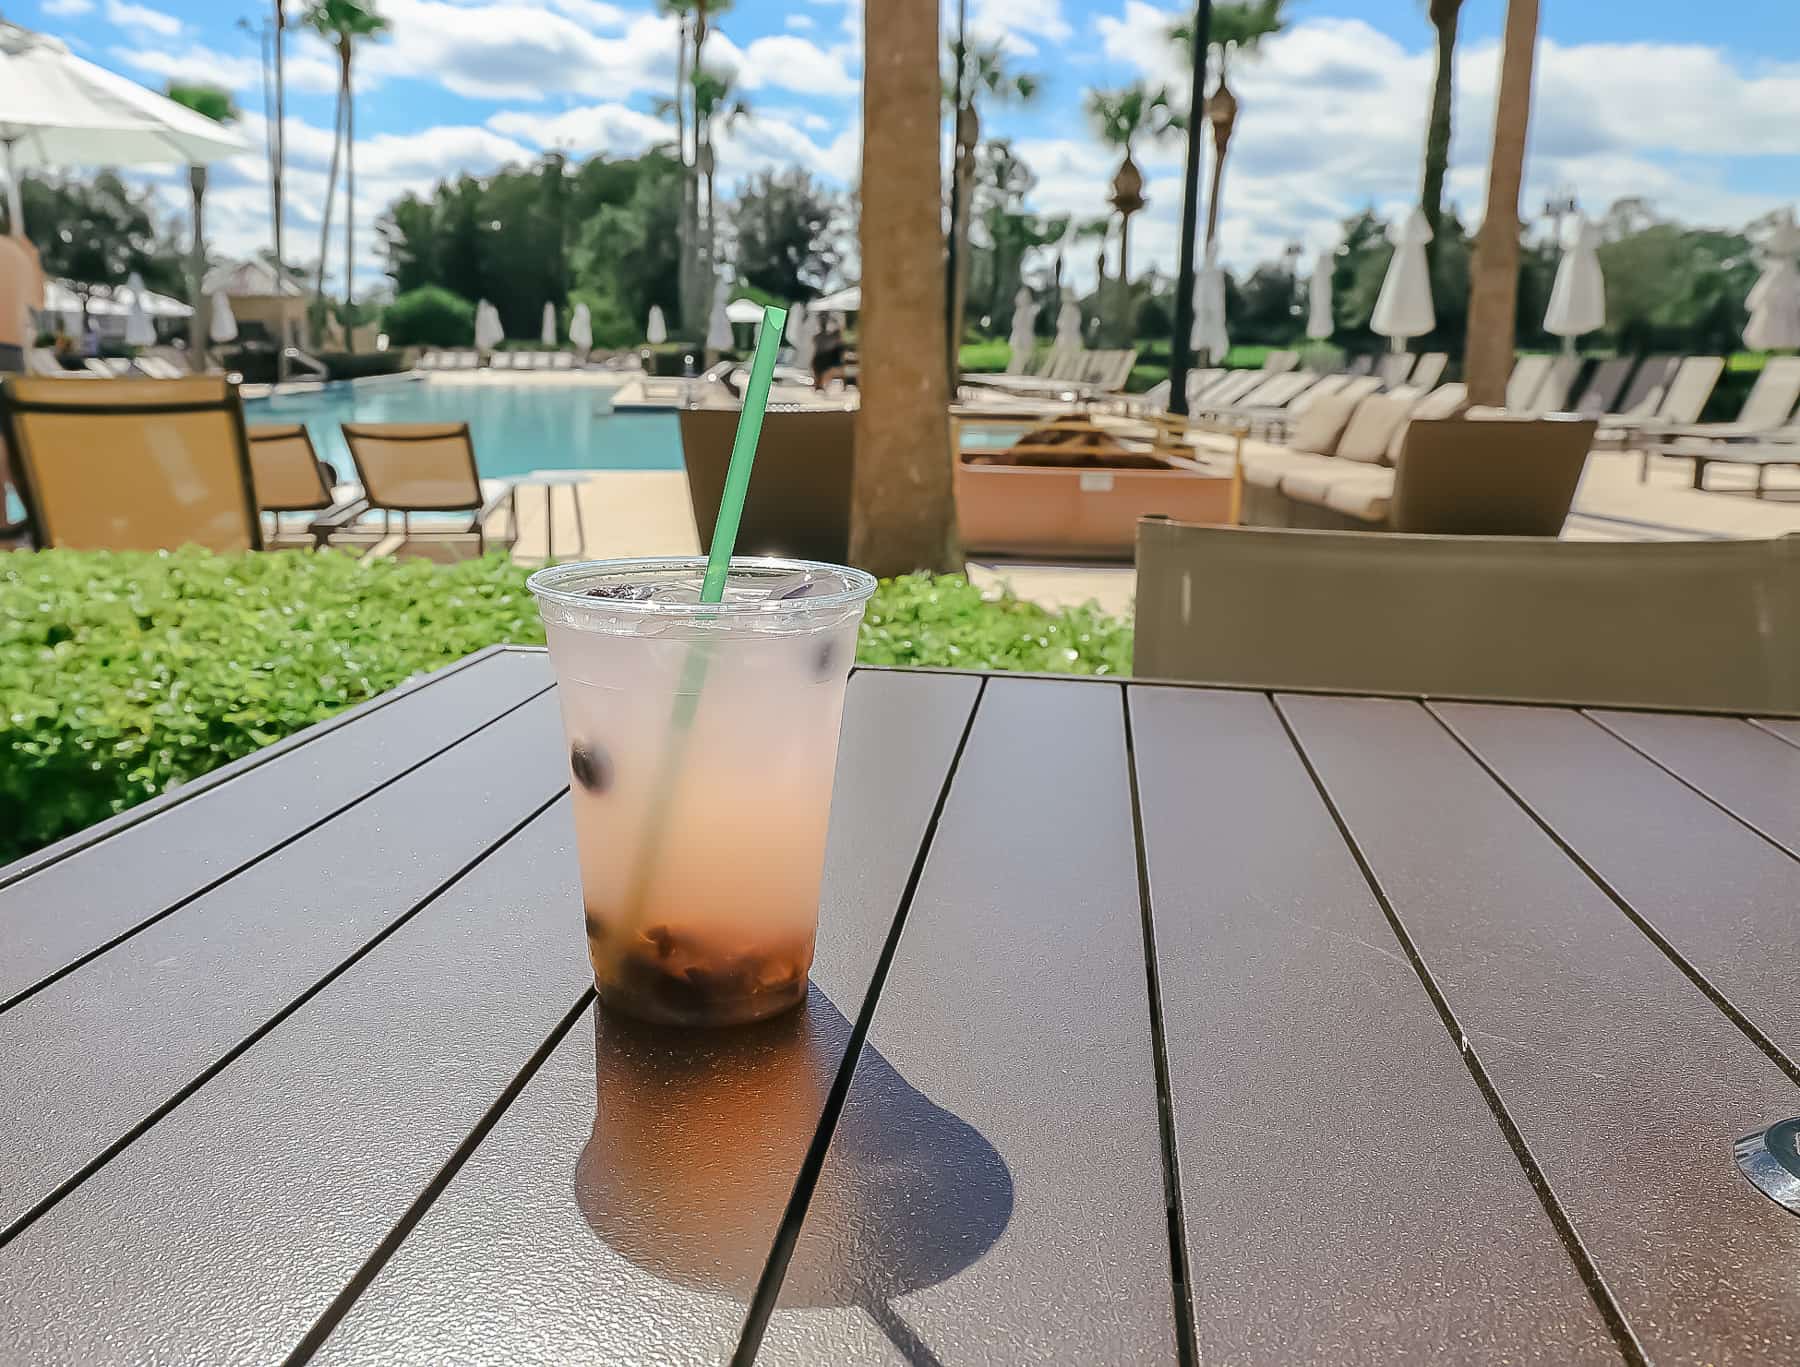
[0, 22, 250, 236]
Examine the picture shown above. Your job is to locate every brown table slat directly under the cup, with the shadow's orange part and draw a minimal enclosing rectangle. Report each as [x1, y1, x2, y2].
[315, 672, 979, 1367]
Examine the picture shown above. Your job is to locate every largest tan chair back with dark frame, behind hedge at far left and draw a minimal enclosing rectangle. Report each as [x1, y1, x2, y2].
[0, 376, 263, 551]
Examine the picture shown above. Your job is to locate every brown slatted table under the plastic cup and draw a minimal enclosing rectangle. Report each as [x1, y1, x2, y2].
[0, 650, 1800, 1367]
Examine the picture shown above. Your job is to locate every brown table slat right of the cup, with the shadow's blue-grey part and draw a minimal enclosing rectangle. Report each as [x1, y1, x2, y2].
[758, 679, 1175, 1363]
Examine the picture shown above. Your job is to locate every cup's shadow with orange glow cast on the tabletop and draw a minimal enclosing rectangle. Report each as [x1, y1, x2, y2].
[574, 985, 1013, 1362]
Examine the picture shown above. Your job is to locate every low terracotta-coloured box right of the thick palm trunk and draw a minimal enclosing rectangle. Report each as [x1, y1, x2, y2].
[956, 452, 1235, 560]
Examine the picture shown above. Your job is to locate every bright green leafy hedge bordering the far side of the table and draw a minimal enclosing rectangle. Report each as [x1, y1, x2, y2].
[0, 549, 1130, 863]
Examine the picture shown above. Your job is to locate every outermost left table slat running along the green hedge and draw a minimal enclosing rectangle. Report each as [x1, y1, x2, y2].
[0, 652, 551, 1003]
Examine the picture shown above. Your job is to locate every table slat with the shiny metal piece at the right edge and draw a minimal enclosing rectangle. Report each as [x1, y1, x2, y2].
[1280, 697, 1800, 1365]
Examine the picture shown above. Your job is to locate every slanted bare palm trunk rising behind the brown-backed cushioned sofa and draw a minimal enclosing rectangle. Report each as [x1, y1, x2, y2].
[1463, 0, 1537, 403]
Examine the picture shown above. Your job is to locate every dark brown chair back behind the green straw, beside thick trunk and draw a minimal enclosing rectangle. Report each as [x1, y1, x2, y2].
[680, 405, 857, 564]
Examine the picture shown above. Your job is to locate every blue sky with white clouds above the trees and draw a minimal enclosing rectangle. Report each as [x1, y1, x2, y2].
[14, 0, 1800, 288]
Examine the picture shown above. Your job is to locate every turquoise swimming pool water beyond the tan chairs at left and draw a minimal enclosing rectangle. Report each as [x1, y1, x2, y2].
[243, 380, 680, 479]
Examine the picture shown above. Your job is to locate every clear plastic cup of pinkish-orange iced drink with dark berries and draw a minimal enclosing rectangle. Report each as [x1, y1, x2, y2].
[529, 557, 875, 1025]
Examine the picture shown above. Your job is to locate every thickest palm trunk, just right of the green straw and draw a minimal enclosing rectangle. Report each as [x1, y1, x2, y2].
[850, 4, 963, 575]
